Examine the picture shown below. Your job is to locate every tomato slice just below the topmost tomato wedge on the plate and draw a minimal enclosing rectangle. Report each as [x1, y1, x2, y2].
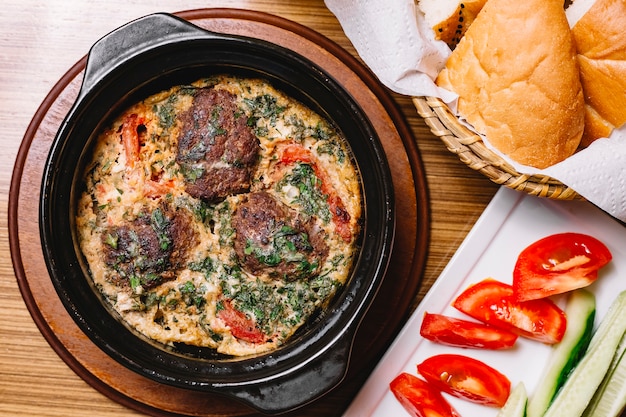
[452, 278, 567, 344]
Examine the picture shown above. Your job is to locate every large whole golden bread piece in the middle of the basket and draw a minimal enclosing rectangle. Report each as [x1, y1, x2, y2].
[436, 0, 584, 168]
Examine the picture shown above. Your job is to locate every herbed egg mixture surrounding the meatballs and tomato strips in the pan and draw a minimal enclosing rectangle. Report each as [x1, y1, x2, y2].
[76, 76, 362, 356]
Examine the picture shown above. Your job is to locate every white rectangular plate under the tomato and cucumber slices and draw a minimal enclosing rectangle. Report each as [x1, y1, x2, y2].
[344, 187, 626, 417]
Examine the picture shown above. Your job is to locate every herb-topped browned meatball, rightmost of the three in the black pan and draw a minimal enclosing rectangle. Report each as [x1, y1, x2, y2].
[232, 191, 328, 281]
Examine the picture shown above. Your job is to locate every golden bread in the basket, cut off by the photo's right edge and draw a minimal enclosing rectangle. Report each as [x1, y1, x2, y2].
[568, 0, 626, 146]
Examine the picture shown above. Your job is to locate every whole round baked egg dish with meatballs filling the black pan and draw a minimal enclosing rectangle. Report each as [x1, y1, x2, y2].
[76, 76, 362, 356]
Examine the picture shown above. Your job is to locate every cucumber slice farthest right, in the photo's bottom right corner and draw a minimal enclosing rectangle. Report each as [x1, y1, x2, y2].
[583, 330, 626, 417]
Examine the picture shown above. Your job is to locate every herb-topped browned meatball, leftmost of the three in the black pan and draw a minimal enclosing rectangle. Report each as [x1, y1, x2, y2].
[102, 207, 198, 288]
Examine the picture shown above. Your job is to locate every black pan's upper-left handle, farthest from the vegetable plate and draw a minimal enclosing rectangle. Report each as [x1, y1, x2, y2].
[79, 13, 216, 98]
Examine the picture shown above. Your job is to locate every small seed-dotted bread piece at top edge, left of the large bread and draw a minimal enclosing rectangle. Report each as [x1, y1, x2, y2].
[418, 0, 487, 49]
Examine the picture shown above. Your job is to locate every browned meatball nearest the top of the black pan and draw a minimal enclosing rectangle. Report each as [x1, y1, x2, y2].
[176, 88, 260, 201]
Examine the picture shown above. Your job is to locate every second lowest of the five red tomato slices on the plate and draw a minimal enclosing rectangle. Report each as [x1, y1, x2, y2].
[417, 354, 511, 407]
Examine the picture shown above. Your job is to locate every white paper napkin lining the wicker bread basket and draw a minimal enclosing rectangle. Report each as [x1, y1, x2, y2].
[325, 0, 626, 221]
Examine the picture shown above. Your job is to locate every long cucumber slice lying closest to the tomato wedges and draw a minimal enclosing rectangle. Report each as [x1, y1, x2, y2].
[526, 289, 596, 417]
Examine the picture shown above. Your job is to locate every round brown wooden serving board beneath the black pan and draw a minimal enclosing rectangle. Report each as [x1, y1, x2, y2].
[9, 9, 429, 416]
